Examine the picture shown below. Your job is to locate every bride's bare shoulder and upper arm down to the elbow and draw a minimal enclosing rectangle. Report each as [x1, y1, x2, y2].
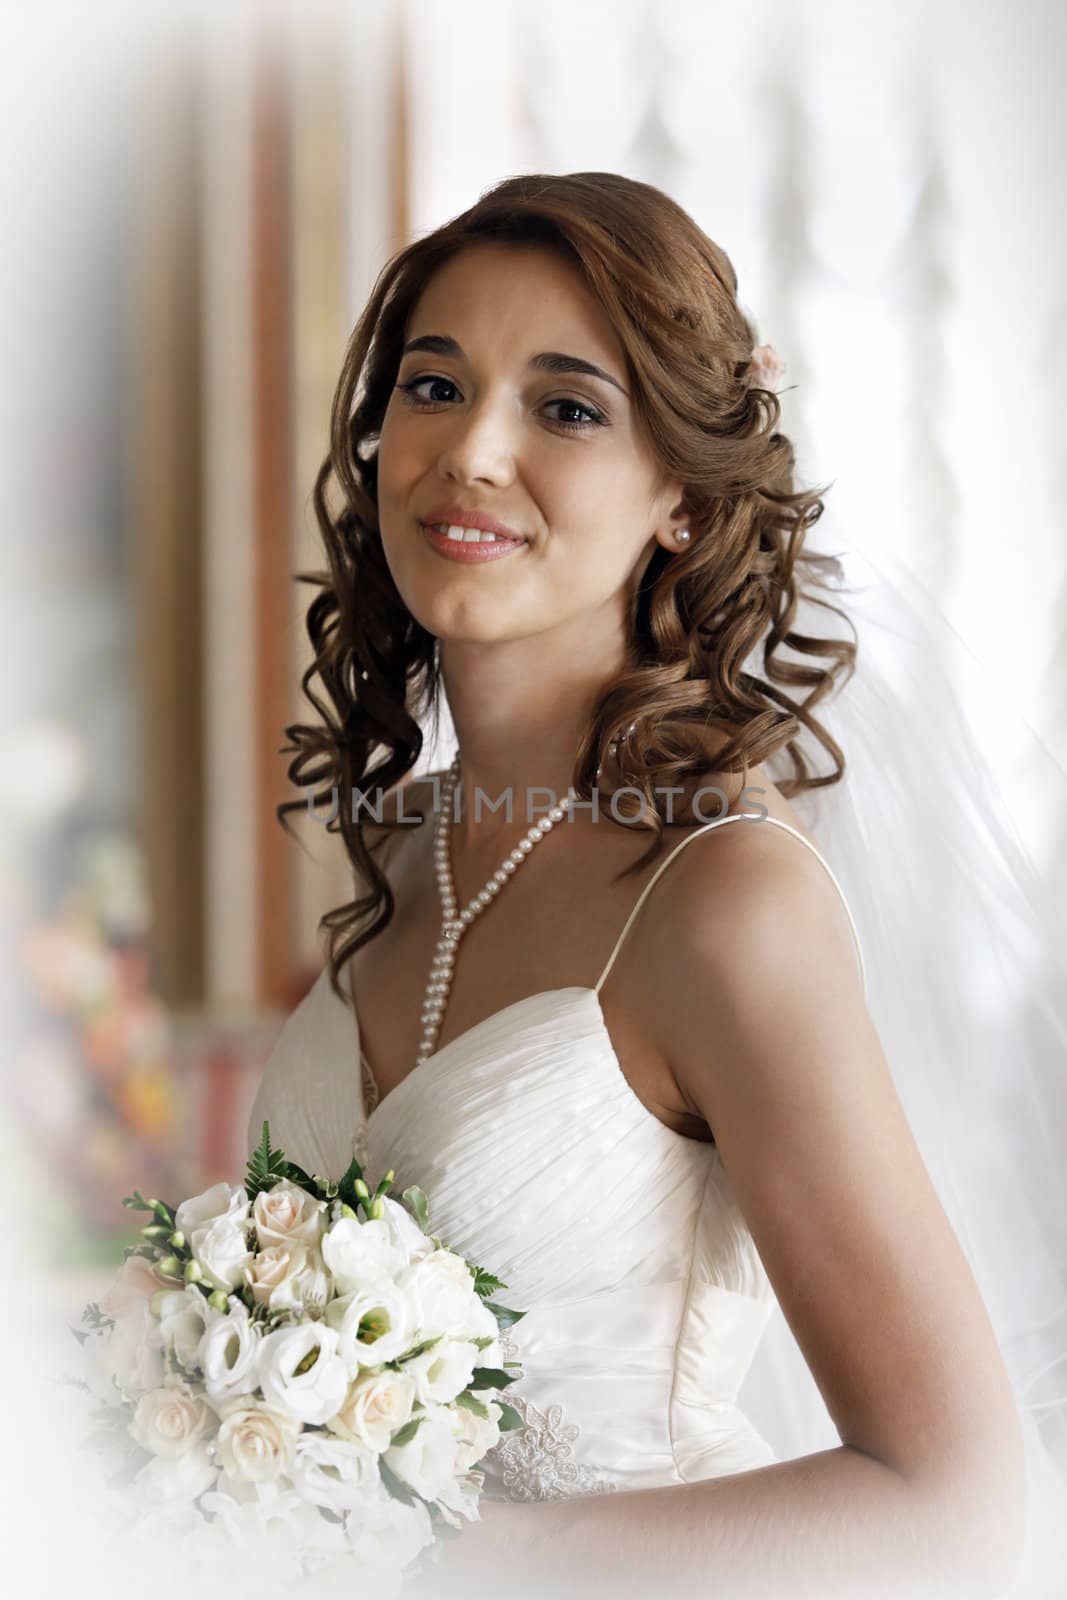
[643, 780, 1016, 1518]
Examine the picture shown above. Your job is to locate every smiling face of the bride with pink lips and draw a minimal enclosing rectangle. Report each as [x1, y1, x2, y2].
[378, 242, 685, 646]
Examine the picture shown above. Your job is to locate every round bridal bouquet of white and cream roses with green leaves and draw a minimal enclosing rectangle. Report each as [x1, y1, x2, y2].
[72, 1122, 523, 1595]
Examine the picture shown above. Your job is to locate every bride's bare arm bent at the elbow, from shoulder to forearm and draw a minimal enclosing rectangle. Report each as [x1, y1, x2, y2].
[441, 824, 1025, 1600]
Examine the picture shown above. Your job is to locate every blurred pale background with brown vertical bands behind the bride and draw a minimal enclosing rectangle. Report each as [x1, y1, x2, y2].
[0, 0, 1067, 1420]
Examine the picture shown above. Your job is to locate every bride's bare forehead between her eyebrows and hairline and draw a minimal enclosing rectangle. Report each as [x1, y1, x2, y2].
[406, 240, 625, 376]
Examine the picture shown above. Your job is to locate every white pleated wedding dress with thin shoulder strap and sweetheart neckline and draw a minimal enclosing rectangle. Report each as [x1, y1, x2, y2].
[248, 814, 862, 1501]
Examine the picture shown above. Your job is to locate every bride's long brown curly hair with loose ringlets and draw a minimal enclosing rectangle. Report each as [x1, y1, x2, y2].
[277, 173, 856, 998]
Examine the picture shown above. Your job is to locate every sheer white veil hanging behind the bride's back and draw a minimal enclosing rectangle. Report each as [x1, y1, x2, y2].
[418, 525, 1067, 1595]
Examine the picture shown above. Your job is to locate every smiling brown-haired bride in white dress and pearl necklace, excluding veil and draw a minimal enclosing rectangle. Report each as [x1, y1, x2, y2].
[250, 173, 1062, 1595]
